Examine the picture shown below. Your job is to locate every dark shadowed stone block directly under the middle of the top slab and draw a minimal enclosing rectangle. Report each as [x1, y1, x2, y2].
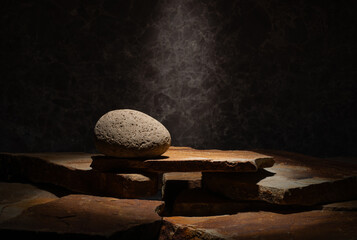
[160, 172, 310, 216]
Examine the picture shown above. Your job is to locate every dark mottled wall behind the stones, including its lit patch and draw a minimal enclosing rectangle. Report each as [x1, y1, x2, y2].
[0, 0, 357, 156]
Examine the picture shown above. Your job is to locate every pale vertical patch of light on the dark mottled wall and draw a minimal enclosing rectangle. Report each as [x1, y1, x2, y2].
[138, 0, 221, 146]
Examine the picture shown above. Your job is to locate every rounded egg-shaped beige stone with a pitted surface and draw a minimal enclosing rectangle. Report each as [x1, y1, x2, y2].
[94, 109, 171, 158]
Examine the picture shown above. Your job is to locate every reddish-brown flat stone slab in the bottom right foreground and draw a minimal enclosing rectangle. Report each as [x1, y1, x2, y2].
[159, 210, 357, 240]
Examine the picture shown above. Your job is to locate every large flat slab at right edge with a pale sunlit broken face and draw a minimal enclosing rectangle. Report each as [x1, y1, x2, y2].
[202, 151, 357, 205]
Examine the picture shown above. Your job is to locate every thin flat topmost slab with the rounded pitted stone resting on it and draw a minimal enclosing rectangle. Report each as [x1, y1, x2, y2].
[91, 147, 274, 172]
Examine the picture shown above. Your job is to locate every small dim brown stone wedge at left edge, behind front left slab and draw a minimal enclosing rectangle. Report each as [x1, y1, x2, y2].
[0, 182, 58, 223]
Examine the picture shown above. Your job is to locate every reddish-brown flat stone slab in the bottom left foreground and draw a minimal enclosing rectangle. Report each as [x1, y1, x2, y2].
[0, 195, 162, 239]
